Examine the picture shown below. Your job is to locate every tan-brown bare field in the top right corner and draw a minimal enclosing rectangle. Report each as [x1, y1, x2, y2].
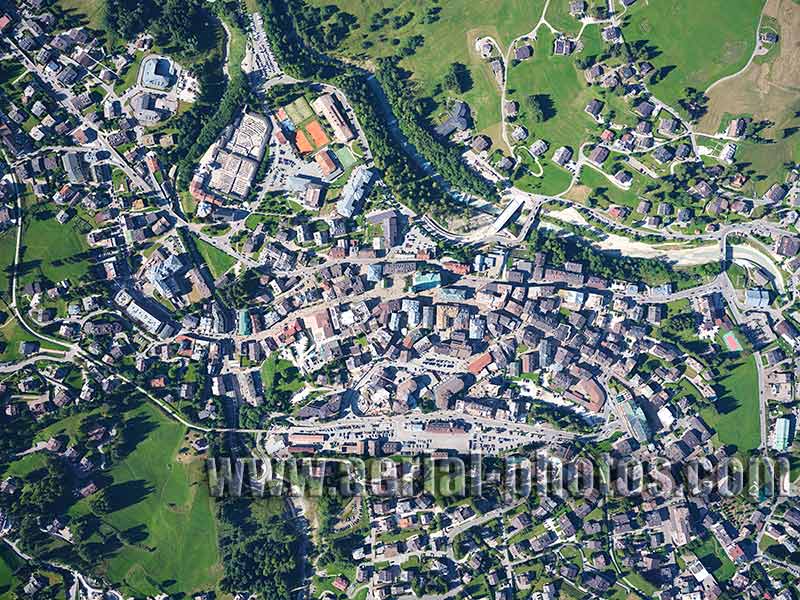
[700, 0, 800, 133]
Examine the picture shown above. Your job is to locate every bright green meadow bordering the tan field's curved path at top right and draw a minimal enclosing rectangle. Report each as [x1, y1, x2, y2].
[623, 0, 764, 105]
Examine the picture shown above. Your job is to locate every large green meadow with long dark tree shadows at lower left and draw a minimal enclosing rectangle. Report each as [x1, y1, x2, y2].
[70, 404, 222, 597]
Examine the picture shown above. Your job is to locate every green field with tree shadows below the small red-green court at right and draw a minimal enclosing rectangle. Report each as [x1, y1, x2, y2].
[701, 355, 761, 452]
